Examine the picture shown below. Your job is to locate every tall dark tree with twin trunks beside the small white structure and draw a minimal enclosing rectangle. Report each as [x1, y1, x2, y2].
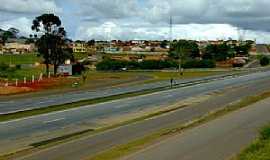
[32, 14, 72, 75]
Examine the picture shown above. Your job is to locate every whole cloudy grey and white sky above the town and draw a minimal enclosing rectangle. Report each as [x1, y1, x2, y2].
[0, 0, 270, 43]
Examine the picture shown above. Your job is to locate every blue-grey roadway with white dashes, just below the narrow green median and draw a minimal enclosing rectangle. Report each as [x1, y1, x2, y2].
[0, 72, 270, 142]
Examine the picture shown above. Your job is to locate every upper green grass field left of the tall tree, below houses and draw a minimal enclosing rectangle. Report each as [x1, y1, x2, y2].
[0, 54, 41, 65]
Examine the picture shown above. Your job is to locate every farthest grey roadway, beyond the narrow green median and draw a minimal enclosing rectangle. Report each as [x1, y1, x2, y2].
[0, 74, 244, 115]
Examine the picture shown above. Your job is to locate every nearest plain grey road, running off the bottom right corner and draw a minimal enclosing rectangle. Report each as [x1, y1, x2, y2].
[123, 99, 270, 160]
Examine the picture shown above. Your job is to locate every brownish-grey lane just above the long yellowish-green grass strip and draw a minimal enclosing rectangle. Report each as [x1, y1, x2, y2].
[15, 75, 270, 160]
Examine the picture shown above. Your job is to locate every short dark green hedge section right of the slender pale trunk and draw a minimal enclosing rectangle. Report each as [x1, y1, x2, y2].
[183, 60, 216, 69]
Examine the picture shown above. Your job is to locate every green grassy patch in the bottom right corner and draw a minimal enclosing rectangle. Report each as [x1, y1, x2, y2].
[234, 125, 270, 160]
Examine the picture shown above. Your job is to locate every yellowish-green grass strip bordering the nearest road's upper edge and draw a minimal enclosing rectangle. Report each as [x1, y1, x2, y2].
[89, 91, 270, 160]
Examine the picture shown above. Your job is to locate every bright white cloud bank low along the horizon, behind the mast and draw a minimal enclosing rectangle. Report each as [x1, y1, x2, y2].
[76, 22, 270, 43]
